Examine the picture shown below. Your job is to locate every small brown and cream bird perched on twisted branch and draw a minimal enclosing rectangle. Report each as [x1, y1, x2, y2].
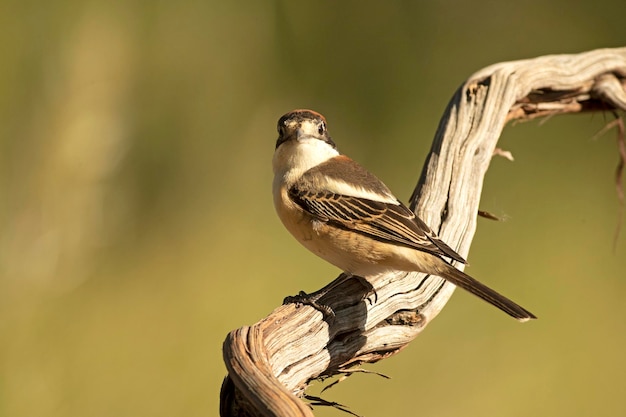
[272, 109, 536, 322]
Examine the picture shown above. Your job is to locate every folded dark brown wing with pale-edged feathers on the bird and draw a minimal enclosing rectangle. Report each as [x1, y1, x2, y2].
[289, 184, 466, 263]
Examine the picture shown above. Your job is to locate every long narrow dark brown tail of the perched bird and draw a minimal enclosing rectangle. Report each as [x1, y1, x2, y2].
[437, 260, 537, 322]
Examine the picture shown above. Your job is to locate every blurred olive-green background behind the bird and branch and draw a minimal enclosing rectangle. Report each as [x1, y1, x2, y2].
[0, 0, 626, 417]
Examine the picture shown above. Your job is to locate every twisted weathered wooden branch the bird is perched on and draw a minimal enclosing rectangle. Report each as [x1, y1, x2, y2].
[220, 48, 626, 416]
